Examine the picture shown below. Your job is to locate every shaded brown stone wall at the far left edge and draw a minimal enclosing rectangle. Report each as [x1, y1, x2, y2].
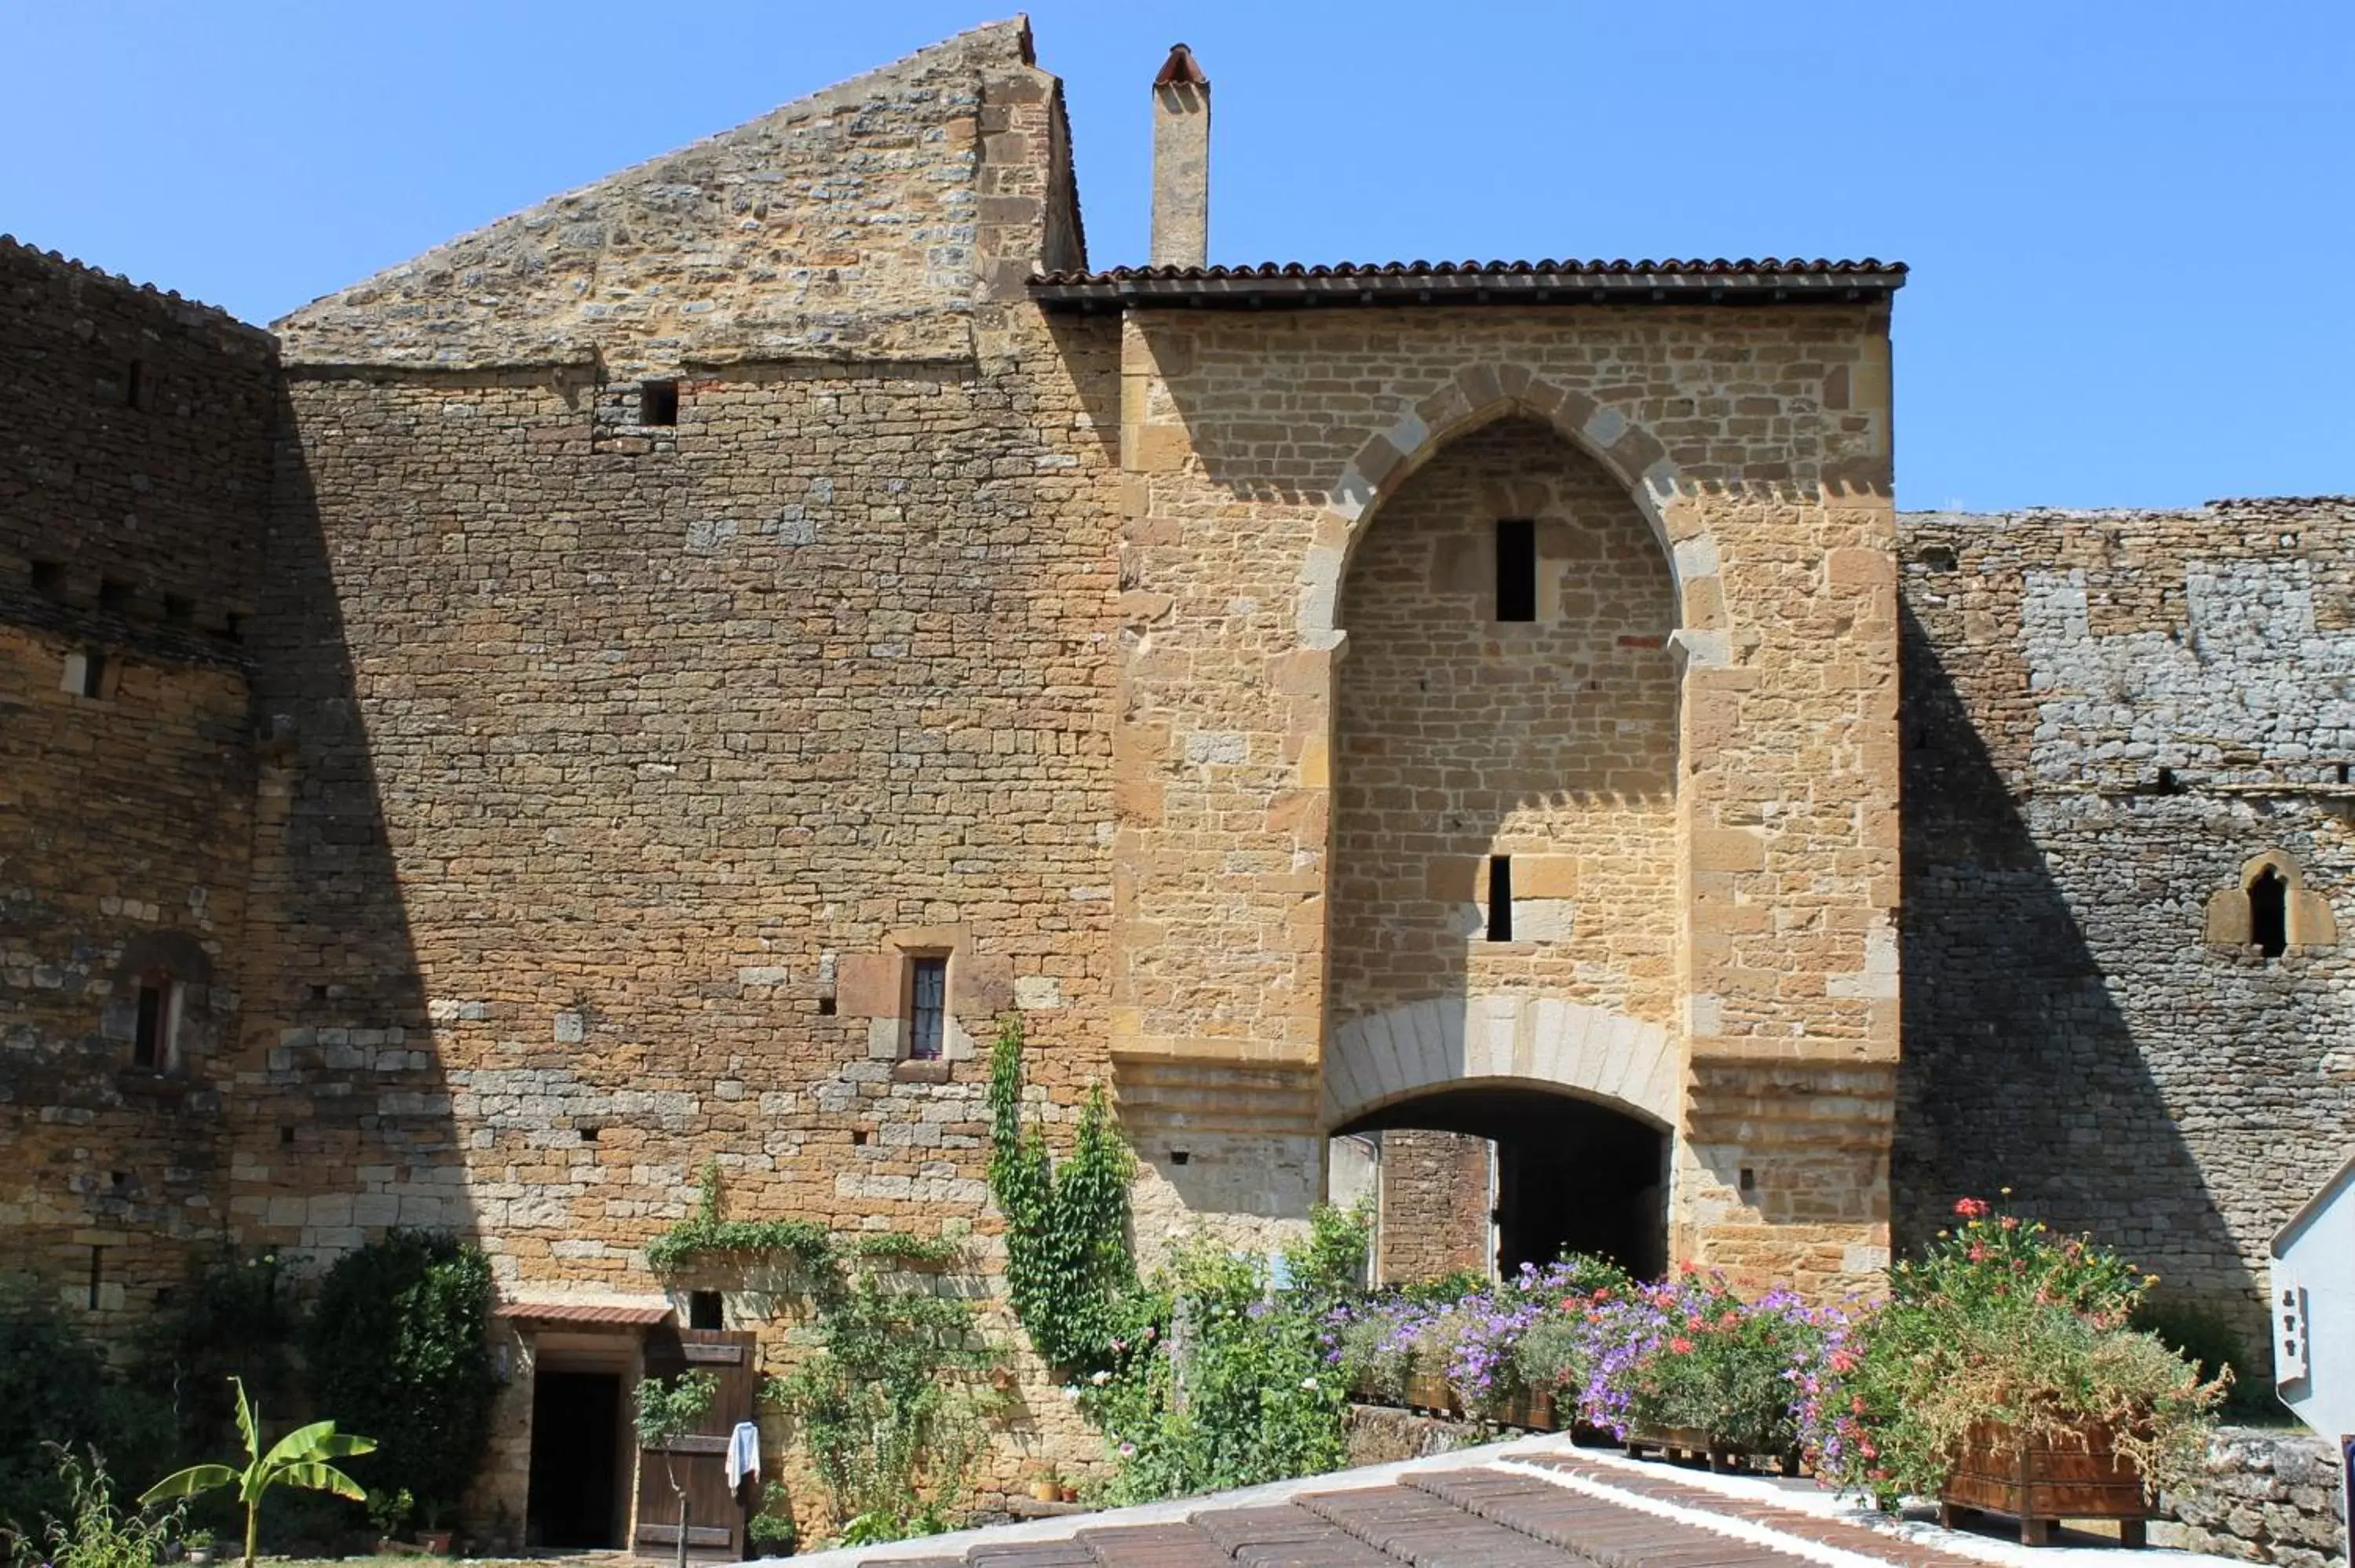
[0, 240, 276, 1330]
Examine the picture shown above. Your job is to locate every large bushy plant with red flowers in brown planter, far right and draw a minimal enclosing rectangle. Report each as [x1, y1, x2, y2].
[1802, 1198, 2230, 1544]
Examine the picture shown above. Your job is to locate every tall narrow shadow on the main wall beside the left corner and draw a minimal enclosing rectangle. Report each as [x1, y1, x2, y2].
[231, 393, 476, 1267]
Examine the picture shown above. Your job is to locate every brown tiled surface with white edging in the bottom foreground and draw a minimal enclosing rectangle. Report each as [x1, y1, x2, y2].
[798, 1439, 2223, 1568]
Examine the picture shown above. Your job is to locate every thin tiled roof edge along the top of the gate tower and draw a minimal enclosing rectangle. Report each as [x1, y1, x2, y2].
[1029, 257, 1905, 311]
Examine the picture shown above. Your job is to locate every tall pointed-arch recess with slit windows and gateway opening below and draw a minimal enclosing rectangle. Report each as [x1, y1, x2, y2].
[1324, 414, 1681, 1278]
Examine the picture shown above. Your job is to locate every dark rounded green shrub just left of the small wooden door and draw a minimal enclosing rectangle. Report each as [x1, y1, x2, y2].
[304, 1231, 497, 1519]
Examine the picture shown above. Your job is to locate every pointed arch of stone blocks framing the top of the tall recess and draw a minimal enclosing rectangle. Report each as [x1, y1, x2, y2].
[1298, 363, 1722, 640]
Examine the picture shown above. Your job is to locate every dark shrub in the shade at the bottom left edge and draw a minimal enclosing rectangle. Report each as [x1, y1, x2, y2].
[0, 1297, 172, 1530]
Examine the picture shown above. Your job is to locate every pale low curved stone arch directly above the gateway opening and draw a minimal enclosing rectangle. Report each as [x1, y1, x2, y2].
[1324, 994, 1684, 1130]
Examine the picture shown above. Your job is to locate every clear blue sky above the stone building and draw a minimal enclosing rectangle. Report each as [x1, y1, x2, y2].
[0, 0, 2355, 509]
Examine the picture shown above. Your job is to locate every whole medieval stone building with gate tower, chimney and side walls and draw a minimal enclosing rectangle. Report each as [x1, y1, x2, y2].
[0, 21, 2355, 1533]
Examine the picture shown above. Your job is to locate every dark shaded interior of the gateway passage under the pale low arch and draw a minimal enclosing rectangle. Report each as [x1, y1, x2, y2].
[1333, 1088, 1667, 1278]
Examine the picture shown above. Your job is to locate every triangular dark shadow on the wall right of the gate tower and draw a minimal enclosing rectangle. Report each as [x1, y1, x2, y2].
[1891, 607, 2268, 1328]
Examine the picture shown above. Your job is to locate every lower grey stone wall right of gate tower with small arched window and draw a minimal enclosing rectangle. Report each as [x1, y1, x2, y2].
[1896, 499, 2355, 1356]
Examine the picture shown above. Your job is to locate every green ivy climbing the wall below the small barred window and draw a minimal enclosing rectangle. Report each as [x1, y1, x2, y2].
[989, 1015, 1152, 1373]
